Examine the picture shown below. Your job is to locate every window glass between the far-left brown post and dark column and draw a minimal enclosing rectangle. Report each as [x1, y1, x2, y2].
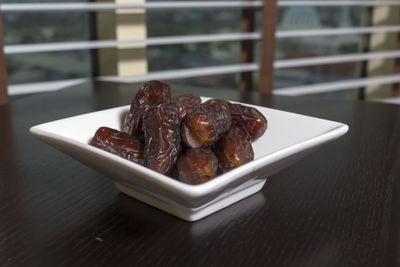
[3, 0, 92, 84]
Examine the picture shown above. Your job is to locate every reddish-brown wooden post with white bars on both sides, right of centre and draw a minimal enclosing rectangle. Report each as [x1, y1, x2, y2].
[259, 0, 278, 93]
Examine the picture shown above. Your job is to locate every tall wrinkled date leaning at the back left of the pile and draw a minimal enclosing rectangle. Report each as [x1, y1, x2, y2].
[122, 81, 171, 136]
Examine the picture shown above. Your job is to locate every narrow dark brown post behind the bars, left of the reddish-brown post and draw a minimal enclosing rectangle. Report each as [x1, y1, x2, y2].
[239, 0, 256, 91]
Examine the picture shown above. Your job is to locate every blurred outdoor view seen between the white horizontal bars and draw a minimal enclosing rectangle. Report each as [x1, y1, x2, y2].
[2, 0, 400, 100]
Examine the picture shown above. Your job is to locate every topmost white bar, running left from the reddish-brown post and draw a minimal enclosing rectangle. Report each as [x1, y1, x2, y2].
[0, 1, 263, 12]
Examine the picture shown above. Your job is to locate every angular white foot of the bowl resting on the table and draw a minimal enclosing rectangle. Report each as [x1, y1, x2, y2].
[114, 178, 267, 222]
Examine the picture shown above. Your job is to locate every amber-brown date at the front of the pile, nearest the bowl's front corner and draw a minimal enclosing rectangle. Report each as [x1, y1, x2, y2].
[177, 148, 218, 185]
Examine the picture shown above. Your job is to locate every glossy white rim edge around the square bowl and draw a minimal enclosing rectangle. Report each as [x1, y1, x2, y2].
[29, 100, 349, 197]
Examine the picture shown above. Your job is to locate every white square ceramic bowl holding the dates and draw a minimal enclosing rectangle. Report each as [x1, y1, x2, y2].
[30, 97, 348, 221]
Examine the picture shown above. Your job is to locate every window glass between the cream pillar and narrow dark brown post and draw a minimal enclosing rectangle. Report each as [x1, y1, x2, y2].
[147, 9, 241, 89]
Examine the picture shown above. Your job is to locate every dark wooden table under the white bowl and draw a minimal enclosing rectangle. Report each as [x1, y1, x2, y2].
[0, 83, 400, 266]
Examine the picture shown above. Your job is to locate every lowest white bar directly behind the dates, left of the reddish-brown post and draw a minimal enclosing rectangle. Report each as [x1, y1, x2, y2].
[97, 63, 259, 83]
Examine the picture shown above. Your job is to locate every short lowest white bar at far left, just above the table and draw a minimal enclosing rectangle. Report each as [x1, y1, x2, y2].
[8, 78, 89, 95]
